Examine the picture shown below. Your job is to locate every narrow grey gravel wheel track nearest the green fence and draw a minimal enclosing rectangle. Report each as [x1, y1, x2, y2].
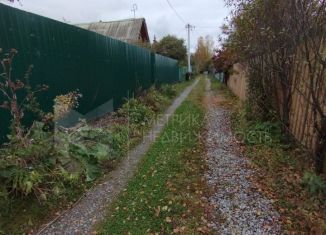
[38, 80, 198, 235]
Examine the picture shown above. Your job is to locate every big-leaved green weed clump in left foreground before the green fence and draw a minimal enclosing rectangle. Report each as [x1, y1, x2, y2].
[0, 119, 126, 204]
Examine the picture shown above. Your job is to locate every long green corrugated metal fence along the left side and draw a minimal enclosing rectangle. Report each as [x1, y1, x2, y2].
[0, 4, 179, 143]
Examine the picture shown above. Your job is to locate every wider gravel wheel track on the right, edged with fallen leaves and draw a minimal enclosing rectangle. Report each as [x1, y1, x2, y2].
[205, 80, 282, 235]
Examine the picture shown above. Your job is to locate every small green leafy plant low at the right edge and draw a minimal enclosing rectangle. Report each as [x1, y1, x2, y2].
[302, 172, 326, 196]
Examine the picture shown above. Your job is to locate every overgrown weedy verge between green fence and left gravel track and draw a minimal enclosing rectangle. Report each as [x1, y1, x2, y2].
[0, 82, 190, 234]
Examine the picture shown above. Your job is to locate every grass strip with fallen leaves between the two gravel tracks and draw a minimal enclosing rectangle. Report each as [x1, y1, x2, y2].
[98, 78, 209, 234]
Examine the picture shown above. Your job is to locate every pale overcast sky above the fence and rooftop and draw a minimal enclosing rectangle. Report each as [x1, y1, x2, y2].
[0, 0, 229, 51]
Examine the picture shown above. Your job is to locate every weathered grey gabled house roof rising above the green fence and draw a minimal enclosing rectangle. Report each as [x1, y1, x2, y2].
[76, 18, 149, 43]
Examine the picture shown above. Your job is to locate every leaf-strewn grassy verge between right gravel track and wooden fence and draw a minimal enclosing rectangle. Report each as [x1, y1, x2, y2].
[214, 77, 326, 234]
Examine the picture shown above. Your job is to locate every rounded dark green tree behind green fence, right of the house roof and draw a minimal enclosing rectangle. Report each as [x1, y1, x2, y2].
[153, 35, 187, 63]
